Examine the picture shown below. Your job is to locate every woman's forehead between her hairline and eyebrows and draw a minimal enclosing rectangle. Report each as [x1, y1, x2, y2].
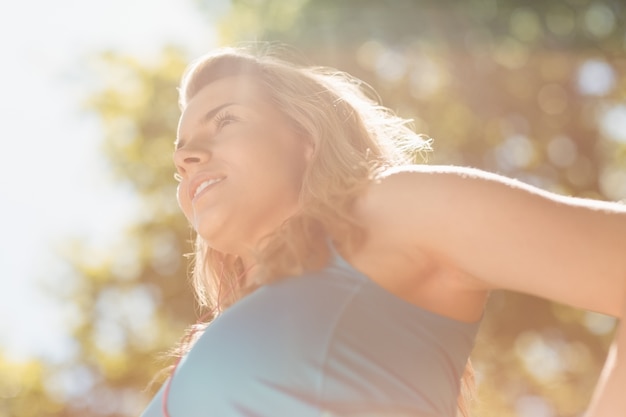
[178, 75, 268, 137]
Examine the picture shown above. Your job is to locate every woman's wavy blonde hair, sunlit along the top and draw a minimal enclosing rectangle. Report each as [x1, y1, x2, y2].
[179, 45, 473, 416]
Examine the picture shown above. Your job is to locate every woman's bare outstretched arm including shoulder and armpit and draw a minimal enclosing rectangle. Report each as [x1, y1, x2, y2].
[346, 166, 626, 321]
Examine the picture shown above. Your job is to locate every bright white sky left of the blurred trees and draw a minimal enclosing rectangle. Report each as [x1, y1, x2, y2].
[0, 0, 219, 358]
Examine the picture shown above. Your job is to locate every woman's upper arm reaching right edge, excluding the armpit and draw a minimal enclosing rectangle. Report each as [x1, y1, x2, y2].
[372, 167, 626, 315]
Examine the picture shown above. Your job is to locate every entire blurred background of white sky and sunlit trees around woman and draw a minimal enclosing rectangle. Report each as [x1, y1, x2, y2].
[0, 0, 626, 417]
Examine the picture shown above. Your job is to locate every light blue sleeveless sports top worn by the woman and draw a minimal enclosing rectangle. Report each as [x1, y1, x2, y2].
[142, 250, 479, 417]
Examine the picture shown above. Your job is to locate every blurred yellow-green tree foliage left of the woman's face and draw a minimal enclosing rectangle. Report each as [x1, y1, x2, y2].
[0, 47, 195, 417]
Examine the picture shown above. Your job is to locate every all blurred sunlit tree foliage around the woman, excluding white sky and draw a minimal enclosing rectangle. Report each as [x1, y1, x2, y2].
[6, 0, 626, 417]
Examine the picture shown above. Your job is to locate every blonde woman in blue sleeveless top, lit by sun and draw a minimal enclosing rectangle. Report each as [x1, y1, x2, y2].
[143, 49, 626, 417]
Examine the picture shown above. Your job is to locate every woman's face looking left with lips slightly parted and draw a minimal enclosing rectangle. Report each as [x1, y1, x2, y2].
[174, 76, 311, 256]
